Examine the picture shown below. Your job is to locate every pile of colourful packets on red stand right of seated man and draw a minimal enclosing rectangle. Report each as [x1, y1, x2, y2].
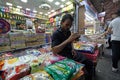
[73, 42, 97, 54]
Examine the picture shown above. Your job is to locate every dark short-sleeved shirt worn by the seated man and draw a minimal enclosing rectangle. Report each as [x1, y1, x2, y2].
[52, 27, 72, 58]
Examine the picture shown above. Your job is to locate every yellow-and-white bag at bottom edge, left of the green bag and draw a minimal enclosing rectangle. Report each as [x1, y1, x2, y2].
[20, 71, 53, 80]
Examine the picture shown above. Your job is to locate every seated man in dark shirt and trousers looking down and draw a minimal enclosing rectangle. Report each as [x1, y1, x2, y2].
[52, 14, 93, 80]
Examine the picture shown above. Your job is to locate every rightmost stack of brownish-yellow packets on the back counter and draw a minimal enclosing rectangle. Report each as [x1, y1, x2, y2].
[25, 33, 45, 47]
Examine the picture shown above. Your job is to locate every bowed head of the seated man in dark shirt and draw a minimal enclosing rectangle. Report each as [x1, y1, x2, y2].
[61, 14, 73, 30]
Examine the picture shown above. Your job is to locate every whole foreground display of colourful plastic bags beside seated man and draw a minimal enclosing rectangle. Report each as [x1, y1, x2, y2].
[0, 46, 84, 80]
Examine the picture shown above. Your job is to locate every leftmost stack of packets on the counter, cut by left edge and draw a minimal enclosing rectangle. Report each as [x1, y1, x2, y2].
[0, 34, 10, 51]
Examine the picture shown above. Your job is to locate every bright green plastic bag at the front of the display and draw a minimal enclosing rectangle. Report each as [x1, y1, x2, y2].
[45, 59, 84, 80]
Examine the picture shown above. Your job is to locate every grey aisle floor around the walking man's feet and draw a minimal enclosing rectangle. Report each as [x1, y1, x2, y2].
[95, 49, 120, 80]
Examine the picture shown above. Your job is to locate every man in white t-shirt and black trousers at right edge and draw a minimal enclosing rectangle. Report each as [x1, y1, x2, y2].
[99, 10, 120, 72]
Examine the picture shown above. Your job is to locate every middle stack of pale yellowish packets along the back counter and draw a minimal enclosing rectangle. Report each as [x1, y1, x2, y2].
[9, 32, 26, 49]
